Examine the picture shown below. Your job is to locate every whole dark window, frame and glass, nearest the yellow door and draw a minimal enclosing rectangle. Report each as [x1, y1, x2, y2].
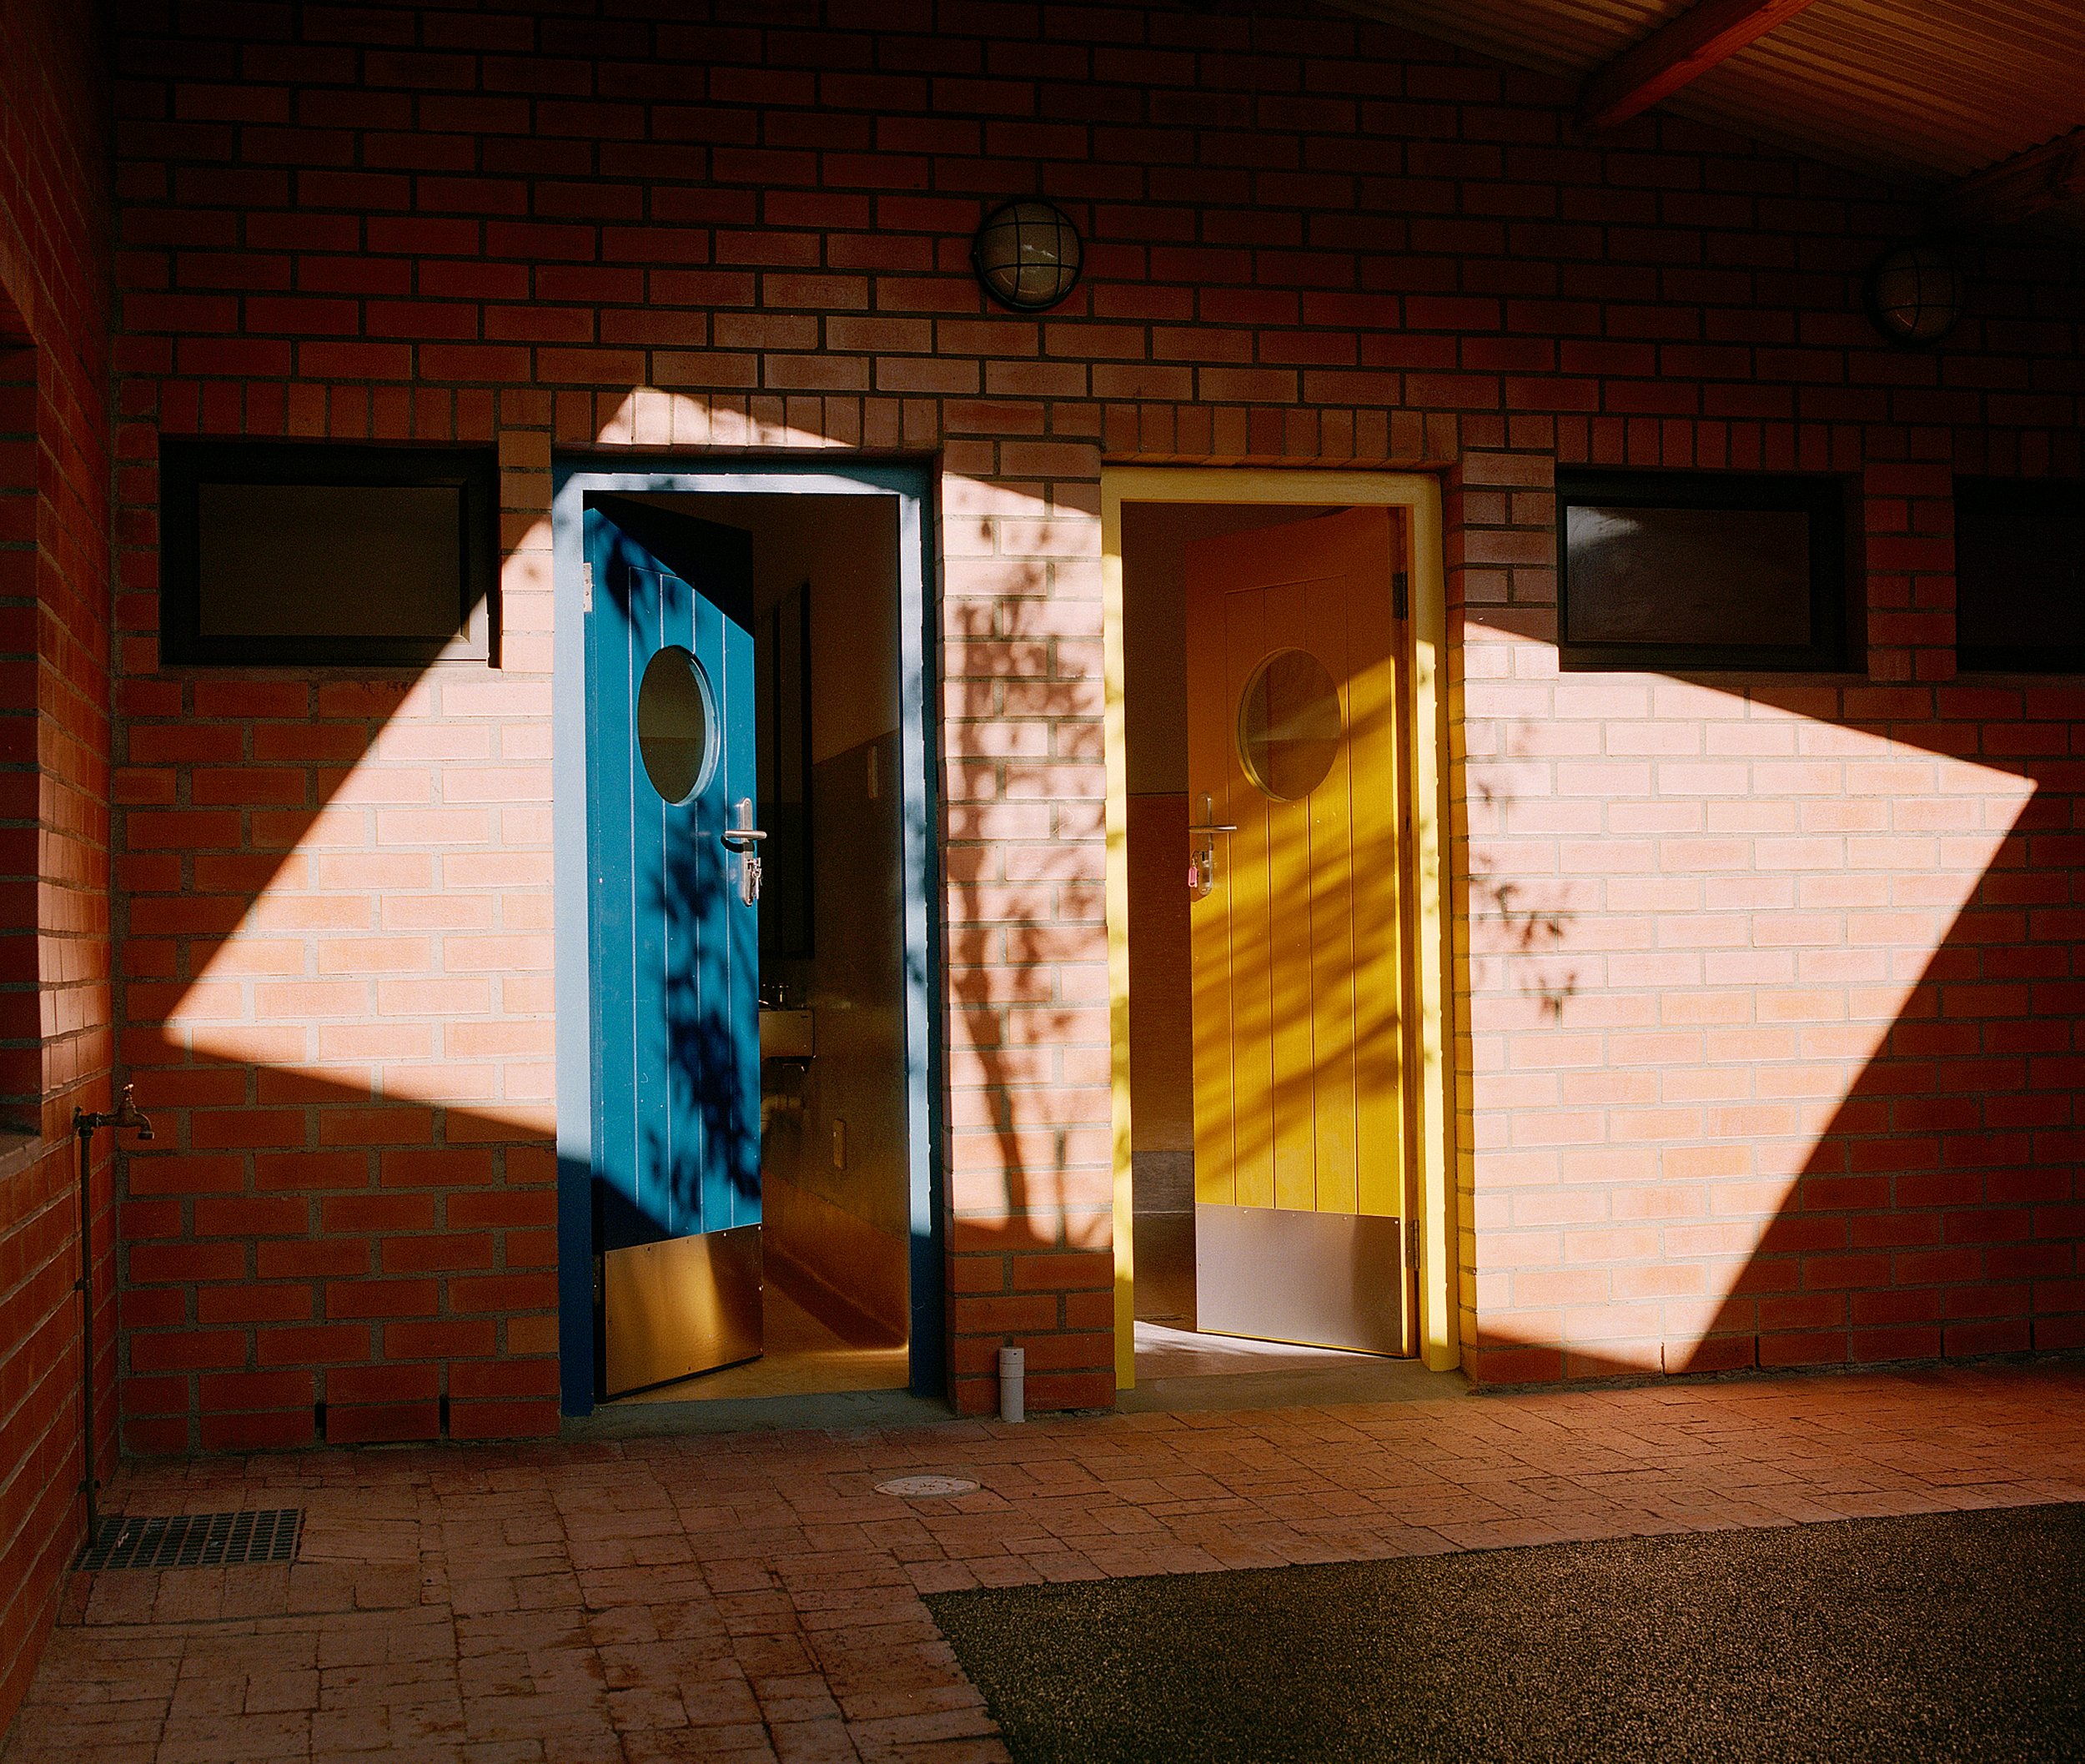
[1558, 471, 1847, 670]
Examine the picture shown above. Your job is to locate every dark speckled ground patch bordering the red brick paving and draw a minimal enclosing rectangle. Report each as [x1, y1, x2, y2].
[926, 1505, 2085, 1764]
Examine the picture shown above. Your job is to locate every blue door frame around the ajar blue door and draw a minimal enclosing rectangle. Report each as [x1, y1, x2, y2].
[550, 459, 947, 1416]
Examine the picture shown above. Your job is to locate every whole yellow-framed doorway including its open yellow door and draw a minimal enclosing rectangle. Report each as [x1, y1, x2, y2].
[1108, 471, 1454, 1387]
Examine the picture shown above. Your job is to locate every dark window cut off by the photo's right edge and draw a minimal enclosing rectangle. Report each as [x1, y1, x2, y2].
[1956, 478, 2085, 674]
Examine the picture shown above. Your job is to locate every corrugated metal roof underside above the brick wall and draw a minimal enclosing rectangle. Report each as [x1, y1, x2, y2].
[1337, 0, 2085, 213]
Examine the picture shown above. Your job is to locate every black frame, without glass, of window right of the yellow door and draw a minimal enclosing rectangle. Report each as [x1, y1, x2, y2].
[1555, 467, 1858, 674]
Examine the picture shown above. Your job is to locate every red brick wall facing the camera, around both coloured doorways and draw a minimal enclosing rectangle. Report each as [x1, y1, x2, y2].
[119, 0, 2085, 1445]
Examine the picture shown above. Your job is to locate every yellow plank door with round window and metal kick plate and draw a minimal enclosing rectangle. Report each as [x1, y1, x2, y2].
[1187, 509, 1412, 1354]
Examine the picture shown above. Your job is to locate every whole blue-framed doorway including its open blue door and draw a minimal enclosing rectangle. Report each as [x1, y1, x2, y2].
[561, 463, 941, 1414]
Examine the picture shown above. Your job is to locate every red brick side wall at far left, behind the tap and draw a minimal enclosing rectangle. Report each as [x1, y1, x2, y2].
[0, 0, 115, 1726]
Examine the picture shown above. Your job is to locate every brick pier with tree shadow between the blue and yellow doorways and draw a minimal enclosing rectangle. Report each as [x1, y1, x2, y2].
[942, 550, 1116, 1410]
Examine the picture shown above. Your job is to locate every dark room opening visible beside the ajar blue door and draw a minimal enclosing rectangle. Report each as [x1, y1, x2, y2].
[636, 495, 909, 1401]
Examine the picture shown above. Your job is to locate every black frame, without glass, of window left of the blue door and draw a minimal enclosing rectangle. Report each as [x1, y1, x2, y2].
[158, 436, 499, 667]
